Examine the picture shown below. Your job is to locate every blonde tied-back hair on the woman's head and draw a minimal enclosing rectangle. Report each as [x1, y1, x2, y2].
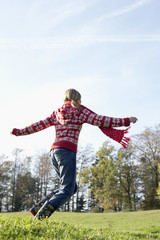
[63, 88, 81, 109]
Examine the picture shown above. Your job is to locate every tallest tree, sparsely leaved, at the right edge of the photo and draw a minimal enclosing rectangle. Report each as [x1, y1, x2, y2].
[135, 124, 160, 209]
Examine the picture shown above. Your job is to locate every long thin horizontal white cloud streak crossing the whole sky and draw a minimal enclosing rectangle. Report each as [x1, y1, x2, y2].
[0, 34, 160, 50]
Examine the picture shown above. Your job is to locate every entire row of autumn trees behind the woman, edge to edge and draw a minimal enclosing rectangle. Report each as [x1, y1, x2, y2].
[0, 124, 160, 212]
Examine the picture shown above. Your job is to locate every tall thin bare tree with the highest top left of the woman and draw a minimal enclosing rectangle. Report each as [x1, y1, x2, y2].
[10, 149, 35, 211]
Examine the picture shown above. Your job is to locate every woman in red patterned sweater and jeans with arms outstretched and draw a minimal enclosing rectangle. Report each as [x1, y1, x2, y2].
[11, 89, 137, 219]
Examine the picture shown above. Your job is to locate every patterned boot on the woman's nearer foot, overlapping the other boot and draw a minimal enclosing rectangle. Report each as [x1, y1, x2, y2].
[34, 201, 56, 220]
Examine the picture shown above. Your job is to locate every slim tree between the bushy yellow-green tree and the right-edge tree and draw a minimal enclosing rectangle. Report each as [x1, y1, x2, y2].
[116, 144, 139, 210]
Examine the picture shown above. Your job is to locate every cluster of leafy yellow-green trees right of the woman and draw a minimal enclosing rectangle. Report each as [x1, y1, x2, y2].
[80, 124, 160, 211]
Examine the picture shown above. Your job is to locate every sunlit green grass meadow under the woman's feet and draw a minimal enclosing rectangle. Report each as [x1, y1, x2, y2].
[0, 210, 160, 240]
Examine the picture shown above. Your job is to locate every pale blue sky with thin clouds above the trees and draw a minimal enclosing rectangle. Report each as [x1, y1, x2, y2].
[0, 0, 160, 155]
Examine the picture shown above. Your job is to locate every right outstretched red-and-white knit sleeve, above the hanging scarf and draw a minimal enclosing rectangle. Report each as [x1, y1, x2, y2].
[83, 107, 130, 128]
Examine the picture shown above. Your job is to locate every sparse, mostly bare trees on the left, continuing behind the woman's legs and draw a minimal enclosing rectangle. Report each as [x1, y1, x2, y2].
[0, 145, 95, 212]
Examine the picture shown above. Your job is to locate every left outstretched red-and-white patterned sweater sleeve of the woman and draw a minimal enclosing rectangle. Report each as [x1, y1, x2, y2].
[12, 112, 56, 136]
